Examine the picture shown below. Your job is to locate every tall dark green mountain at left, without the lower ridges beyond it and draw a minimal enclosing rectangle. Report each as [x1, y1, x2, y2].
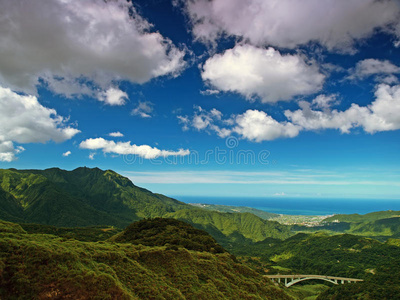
[0, 168, 191, 227]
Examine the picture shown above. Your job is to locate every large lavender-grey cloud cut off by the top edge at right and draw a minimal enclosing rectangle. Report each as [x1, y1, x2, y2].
[182, 0, 400, 52]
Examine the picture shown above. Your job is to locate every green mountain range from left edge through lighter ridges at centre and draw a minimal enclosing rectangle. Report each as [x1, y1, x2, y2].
[0, 168, 291, 242]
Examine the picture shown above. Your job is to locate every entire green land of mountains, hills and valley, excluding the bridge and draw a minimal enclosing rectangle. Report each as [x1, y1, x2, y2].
[0, 168, 400, 300]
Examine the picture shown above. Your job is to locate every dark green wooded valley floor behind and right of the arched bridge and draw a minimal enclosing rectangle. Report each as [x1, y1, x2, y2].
[228, 233, 400, 300]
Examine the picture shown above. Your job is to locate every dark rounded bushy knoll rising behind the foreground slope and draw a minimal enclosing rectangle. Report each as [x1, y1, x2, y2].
[111, 218, 226, 253]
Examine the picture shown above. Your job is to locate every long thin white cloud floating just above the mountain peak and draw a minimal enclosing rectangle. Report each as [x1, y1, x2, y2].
[79, 138, 190, 159]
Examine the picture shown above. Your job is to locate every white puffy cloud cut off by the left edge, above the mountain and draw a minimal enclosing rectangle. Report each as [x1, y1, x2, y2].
[0, 87, 80, 161]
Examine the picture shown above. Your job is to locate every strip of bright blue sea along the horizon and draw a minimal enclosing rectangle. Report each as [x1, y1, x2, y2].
[174, 196, 400, 215]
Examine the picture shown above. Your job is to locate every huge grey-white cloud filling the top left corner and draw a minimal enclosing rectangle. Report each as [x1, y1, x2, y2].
[0, 0, 185, 98]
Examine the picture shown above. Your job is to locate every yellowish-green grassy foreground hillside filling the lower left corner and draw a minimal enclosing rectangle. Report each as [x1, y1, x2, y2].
[0, 219, 291, 300]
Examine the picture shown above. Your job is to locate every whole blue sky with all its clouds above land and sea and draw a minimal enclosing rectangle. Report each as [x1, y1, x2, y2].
[0, 0, 400, 199]
